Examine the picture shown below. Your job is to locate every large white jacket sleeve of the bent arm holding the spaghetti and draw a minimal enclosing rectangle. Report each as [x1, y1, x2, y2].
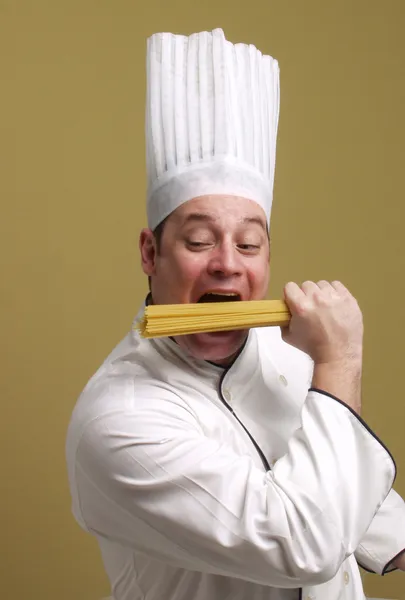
[74, 390, 395, 588]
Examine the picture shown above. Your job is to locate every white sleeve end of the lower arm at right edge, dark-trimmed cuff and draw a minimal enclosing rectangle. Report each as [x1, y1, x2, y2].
[355, 490, 405, 575]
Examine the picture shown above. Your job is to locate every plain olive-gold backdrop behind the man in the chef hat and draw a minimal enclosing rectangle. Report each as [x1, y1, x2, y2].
[0, 0, 405, 600]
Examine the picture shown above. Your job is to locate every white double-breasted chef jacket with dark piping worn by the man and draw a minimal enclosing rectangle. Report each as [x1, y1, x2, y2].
[67, 310, 405, 600]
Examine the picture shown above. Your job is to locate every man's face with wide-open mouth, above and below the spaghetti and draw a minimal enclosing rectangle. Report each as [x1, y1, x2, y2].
[140, 196, 270, 365]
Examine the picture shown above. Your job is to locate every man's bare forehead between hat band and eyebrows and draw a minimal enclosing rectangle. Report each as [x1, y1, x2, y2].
[172, 195, 267, 228]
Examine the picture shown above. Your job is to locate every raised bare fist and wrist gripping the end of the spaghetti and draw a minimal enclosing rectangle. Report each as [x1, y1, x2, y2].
[282, 281, 363, 413]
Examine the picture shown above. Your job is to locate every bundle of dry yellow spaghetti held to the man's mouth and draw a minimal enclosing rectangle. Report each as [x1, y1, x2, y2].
[137, 300, 291, 338]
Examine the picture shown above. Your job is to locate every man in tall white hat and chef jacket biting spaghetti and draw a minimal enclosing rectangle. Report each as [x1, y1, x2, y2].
[67, 29, 405, 600]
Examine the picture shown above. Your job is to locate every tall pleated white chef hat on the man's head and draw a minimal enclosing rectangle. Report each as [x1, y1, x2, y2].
[146, 29, 279, 230]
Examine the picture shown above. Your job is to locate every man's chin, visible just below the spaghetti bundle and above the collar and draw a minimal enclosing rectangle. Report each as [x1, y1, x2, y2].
[175, 330, 248, 366]
